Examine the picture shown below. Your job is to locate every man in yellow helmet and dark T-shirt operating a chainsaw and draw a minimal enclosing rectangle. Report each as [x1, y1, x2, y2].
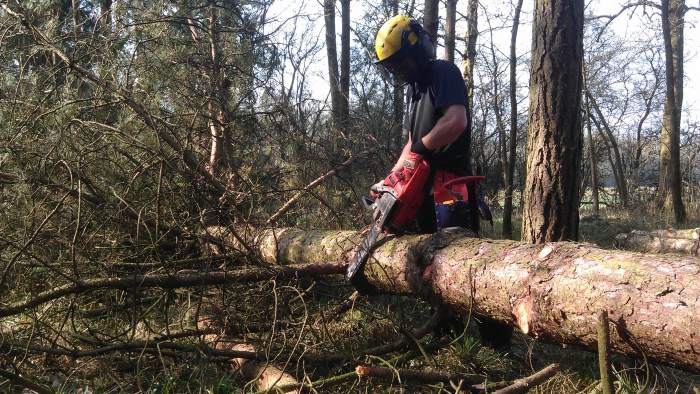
[371, 15, 513, 349]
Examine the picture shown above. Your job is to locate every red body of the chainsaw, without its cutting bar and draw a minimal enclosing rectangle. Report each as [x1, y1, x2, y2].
[375, 159, 430, 234]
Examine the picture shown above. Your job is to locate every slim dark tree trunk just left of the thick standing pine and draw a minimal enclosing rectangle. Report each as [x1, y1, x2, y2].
[503, 0, 523, 239]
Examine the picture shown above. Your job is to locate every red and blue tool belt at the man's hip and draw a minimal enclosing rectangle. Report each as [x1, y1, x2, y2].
[433, 170, 486, 233]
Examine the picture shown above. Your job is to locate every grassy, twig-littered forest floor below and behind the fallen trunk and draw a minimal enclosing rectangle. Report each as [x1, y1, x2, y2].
[5, 202, 700, 394]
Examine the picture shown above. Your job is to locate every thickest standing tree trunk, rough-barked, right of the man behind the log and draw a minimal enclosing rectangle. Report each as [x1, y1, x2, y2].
[522, 0, 584, 243]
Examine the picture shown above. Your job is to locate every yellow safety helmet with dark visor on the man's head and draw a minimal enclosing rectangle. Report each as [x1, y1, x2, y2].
[374, 15, 435, 86]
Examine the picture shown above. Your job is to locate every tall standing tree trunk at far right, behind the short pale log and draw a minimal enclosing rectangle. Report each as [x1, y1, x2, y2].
[659, 0, 687, 225]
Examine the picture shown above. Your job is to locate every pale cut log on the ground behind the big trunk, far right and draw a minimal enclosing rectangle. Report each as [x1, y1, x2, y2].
[615, 228, 700, 256]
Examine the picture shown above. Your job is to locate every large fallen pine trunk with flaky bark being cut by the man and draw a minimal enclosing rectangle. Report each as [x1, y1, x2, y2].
[254, 229, 700, 373]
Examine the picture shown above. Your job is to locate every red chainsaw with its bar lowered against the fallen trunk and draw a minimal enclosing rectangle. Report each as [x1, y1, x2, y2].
[345, 159, 430, 288]
